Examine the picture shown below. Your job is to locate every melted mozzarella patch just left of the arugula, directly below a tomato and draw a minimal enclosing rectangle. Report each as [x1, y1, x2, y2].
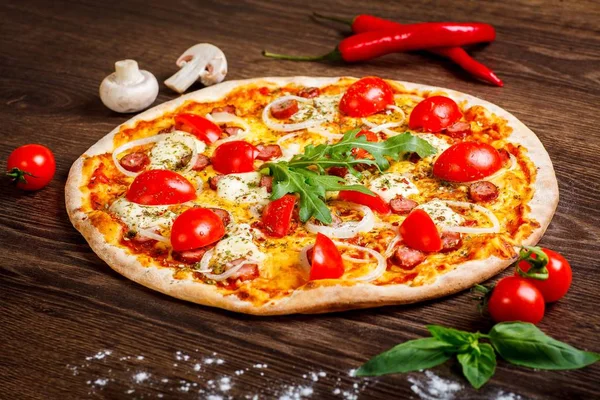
[217, 172, 269, 203]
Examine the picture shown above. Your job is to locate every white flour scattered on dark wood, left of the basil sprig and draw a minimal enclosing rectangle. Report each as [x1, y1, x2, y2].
[67, 349, 370, 400]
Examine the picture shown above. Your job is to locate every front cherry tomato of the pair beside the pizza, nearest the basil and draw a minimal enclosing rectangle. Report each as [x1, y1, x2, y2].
[488, 276, 545, 324]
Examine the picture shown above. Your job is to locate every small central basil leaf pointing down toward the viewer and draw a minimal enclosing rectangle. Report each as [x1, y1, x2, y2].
[456, 343, 496, 389]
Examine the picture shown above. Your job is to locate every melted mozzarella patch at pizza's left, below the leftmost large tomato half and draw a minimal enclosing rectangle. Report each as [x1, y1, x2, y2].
[110, 197, 177, 230]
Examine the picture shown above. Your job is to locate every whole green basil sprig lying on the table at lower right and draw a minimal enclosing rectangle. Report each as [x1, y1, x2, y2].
[356, 322, 600, 389]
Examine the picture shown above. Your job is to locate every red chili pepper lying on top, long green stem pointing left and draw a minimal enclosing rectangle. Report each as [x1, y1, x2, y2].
[263, 22, 496, 62]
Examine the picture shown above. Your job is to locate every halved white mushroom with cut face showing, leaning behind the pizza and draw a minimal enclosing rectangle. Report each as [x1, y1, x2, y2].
[165, 43, 227, 93]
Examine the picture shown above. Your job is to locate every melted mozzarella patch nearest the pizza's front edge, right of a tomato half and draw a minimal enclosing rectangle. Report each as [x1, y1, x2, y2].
[213, 224, 265, 263]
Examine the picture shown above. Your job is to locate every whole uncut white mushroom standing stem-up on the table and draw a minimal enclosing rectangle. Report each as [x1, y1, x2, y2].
[100, 60, 158, 113]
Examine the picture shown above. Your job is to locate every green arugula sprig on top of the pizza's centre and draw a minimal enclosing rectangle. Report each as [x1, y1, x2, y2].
[261, 129, 436, 224]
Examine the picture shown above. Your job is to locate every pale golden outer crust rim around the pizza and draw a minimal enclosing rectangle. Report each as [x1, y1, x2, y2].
[65, 77, 558, 315]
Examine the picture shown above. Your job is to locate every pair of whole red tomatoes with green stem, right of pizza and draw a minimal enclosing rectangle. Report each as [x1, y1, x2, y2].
[487, 247, 572, 324]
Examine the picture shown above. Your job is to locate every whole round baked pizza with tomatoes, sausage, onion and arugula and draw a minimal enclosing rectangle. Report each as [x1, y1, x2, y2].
[65, 77, 558, 315]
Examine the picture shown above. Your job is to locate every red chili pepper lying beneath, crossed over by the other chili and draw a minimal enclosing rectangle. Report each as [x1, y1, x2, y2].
[314, 13, 504, 86]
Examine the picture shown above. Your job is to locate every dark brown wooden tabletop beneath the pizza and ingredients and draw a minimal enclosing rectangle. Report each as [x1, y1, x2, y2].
[0, 0, 600, 399]
